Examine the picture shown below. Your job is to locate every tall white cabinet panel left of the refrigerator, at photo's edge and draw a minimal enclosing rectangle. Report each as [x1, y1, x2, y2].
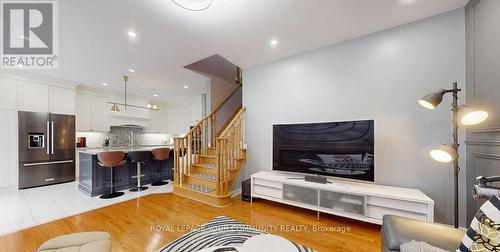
[0, 110, 17, 190]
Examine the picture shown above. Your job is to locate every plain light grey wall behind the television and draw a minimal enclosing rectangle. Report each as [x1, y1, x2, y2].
[243, 9, 468, 223]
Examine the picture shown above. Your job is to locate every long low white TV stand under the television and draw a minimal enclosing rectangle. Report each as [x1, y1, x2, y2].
[251, 171, 434, 224]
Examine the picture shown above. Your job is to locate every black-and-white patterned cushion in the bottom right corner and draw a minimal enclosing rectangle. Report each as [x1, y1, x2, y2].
[457, 196, 500, 252]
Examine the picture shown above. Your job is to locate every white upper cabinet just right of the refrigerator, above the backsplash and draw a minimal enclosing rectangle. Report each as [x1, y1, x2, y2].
[76, 93, 109, 132]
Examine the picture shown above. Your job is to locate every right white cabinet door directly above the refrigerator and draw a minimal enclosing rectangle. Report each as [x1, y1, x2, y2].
[49, 86, 75, 115]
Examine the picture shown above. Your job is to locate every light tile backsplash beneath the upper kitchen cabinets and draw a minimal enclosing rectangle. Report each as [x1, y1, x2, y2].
[76, 127, 172, 147]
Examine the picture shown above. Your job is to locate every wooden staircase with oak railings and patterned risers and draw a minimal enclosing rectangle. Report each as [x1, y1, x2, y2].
[174, 69, 246, 207]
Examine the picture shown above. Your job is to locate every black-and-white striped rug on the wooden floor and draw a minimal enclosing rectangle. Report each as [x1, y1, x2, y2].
[159, 216, 313, 252]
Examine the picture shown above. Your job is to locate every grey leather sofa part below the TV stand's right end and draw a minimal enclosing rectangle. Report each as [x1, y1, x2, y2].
[382, 215, 465, 251]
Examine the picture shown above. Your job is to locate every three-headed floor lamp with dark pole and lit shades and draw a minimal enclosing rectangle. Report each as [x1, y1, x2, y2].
[418, 82, 488, 228]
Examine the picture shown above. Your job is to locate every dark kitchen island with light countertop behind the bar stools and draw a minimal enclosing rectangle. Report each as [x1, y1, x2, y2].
[77, 145, 174, 197]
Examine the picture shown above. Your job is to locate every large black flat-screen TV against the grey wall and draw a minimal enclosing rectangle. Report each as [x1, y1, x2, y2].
[273, 120, 375, 181]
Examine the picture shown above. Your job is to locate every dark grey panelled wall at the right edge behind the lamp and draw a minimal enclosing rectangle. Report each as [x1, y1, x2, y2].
[466, 0, 500, 221]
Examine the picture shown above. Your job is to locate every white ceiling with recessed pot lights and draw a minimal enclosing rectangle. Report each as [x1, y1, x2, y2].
[31, 0, 467, 102]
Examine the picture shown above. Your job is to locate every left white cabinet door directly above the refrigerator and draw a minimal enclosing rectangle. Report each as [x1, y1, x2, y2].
[19, 80, 49, 112]
